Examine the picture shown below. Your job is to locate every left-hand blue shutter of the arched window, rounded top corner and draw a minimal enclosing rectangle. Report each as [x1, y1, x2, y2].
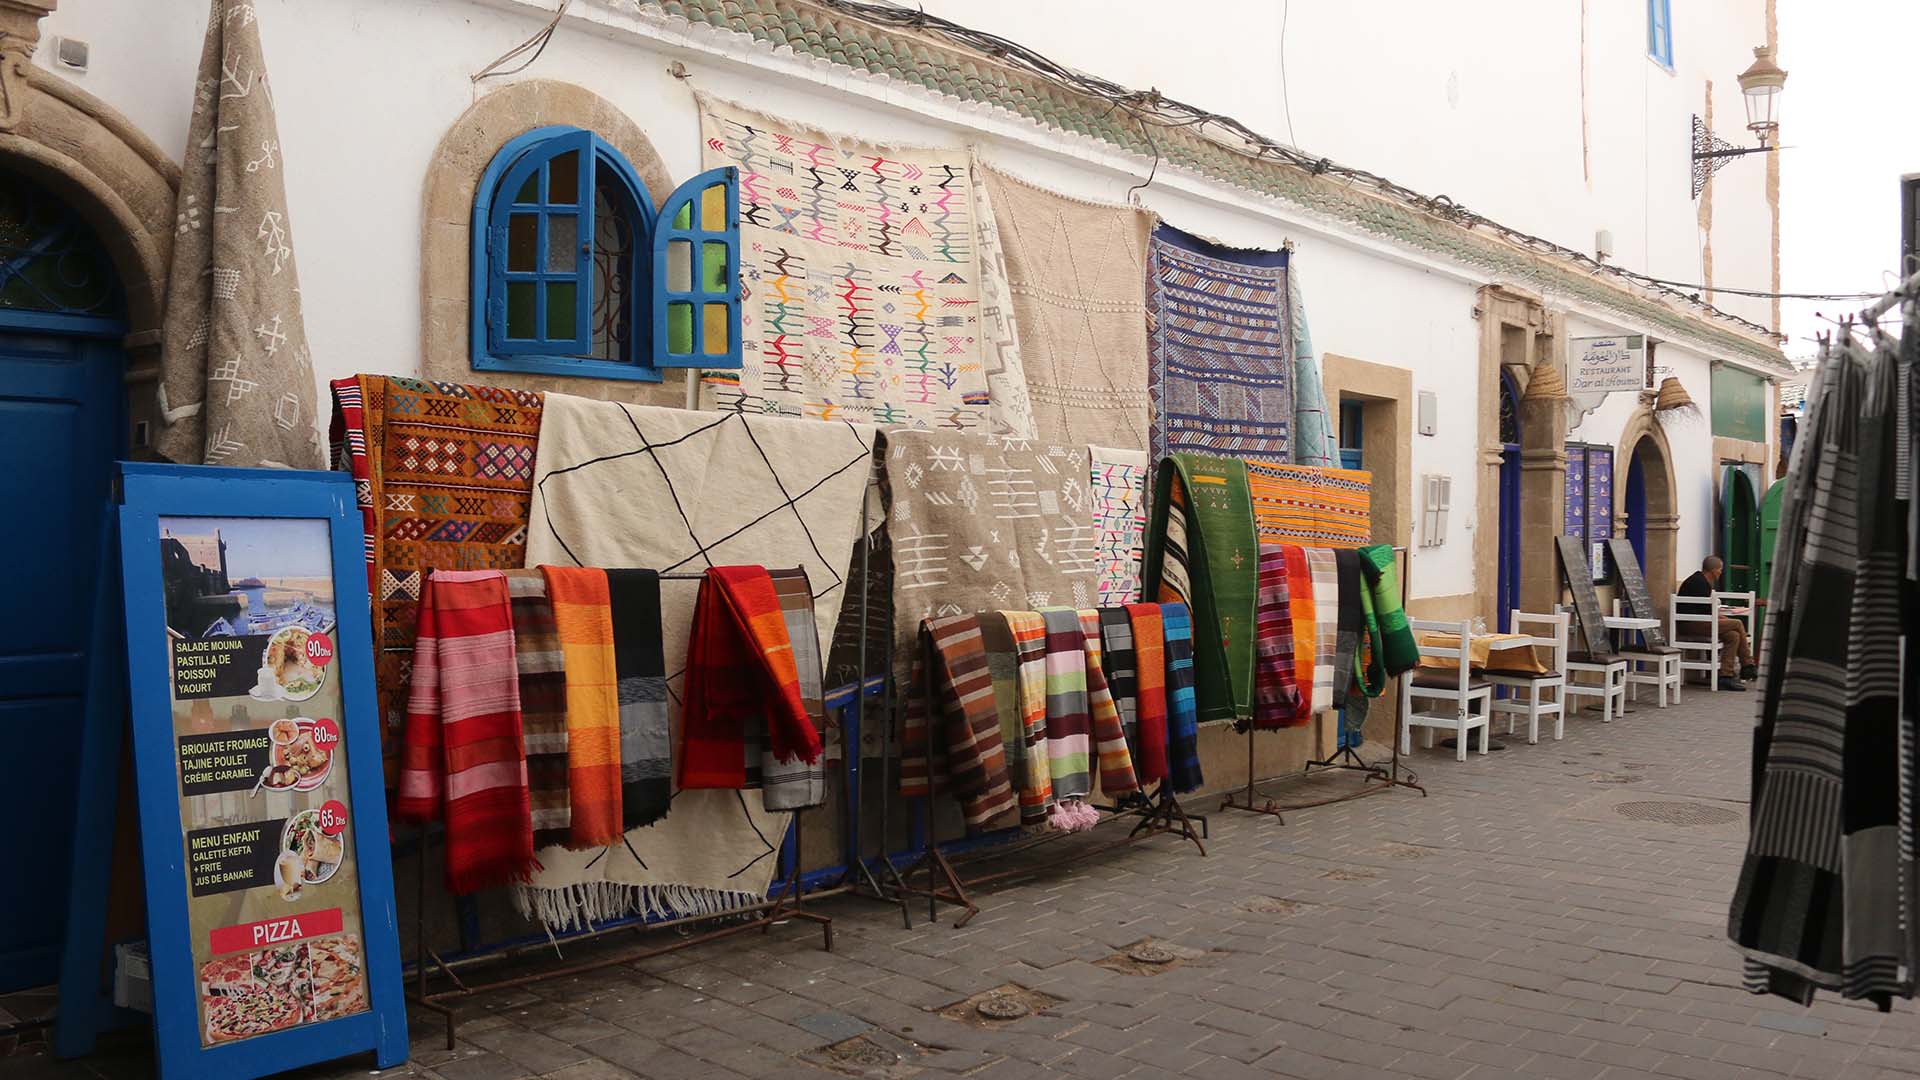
[488, 129, 597, 356]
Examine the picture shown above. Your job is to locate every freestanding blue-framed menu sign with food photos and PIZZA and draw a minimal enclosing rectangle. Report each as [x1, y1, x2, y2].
[112, 463, 407, 1076]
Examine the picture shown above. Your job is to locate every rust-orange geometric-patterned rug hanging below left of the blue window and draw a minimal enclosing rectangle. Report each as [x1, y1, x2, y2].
[332, 375, 541, 784]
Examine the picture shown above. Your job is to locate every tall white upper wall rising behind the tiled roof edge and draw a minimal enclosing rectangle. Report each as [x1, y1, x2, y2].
[922, 0, 1772, 323]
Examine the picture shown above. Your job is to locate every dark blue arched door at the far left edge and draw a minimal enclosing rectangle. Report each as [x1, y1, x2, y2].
[0, 171, 127, 992]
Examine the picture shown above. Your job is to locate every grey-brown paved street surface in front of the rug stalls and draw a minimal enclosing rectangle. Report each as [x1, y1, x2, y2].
[0, 692, 1920, 1080]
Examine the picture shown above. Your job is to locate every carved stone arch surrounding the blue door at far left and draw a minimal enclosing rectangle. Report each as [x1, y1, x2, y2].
[0, 0, 188, 438]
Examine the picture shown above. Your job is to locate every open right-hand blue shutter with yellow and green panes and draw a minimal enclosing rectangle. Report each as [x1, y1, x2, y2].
[651, 165, 741, 369]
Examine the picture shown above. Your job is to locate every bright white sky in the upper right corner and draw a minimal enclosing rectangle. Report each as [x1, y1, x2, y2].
[1774, 0, 1920, 357]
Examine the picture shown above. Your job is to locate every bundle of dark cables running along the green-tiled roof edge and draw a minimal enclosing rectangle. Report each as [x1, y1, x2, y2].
[794, 0, 1781, 340]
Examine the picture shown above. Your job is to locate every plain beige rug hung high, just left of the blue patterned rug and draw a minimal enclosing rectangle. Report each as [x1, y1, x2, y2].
[979, 165, 1154, 450]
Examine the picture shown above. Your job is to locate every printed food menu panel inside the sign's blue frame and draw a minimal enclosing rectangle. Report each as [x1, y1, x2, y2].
[157, 517, 378, 1047]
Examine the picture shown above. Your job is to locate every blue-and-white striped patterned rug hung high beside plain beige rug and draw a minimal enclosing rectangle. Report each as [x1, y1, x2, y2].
[1146, 225, 1294, 461]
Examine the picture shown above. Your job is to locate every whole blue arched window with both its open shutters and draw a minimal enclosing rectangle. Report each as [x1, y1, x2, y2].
[470, 127, 739, 382]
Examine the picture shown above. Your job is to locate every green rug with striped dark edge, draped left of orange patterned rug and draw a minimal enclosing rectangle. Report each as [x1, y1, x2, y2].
[1140, 454, 1260, 721]
